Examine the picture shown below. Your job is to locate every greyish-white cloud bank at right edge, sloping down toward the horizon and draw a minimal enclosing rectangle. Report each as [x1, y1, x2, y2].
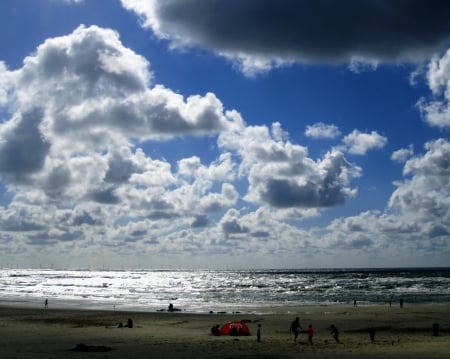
[326, 139, 450, 263]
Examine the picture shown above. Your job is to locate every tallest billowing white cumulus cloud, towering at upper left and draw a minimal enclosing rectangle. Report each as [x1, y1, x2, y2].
[0, 26, 241, 182]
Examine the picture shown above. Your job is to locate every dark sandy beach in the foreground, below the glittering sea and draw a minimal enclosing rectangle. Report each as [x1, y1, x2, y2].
[0, 305, 450, 359]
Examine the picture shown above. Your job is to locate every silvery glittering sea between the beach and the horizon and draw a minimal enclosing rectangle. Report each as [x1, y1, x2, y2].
[0, 268, 450, 313]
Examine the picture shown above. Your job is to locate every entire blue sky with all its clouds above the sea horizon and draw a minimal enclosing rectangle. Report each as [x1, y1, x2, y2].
[0, 0, 450, 269]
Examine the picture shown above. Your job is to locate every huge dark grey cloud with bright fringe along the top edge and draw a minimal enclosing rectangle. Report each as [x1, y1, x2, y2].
[122, 0, 450, 75]
